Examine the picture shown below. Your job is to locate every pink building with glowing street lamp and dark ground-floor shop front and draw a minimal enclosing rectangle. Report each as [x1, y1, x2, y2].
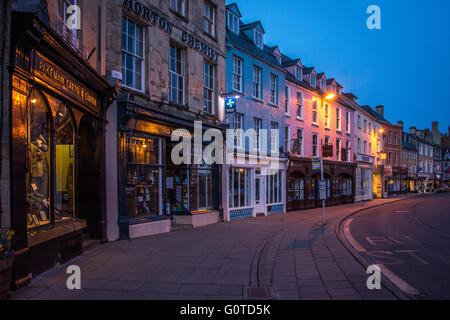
[282, 56, 355, 210]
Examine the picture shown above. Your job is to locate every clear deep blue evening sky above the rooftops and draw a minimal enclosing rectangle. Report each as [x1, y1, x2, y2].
[226, 0, 450, 133]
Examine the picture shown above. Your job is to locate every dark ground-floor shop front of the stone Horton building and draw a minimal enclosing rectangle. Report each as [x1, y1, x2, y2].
[117, 94, 223, 239]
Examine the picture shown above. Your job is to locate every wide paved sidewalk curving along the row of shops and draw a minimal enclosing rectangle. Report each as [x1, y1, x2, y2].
[11, 195, 418, 300]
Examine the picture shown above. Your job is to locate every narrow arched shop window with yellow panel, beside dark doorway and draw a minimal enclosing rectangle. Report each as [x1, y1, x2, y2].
[54, 105, 75, 221]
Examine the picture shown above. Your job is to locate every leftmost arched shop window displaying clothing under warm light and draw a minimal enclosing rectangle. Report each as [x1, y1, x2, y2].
[26, 91, 50, 228]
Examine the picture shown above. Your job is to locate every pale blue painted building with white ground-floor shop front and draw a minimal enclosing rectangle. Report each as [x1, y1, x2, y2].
[224, 4, 287, 221]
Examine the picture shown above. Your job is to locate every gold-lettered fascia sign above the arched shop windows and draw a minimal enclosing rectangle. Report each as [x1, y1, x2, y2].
[32, 53, 98, 113]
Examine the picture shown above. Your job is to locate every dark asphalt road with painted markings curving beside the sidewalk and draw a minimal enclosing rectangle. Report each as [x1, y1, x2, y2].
[349, 193, 450, 299]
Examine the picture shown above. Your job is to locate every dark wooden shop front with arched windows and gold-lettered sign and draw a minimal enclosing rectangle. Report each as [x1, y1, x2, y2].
[11, 12, 115, 288]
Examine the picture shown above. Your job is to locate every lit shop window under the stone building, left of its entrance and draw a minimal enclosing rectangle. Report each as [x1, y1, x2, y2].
[126, 135, 162, 218]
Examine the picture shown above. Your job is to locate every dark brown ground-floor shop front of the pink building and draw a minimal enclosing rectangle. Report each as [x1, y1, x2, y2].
[287, 157, 355, 211]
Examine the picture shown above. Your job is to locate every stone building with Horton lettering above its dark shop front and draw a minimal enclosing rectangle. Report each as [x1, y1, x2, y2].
[101, 0, 225, 240]
